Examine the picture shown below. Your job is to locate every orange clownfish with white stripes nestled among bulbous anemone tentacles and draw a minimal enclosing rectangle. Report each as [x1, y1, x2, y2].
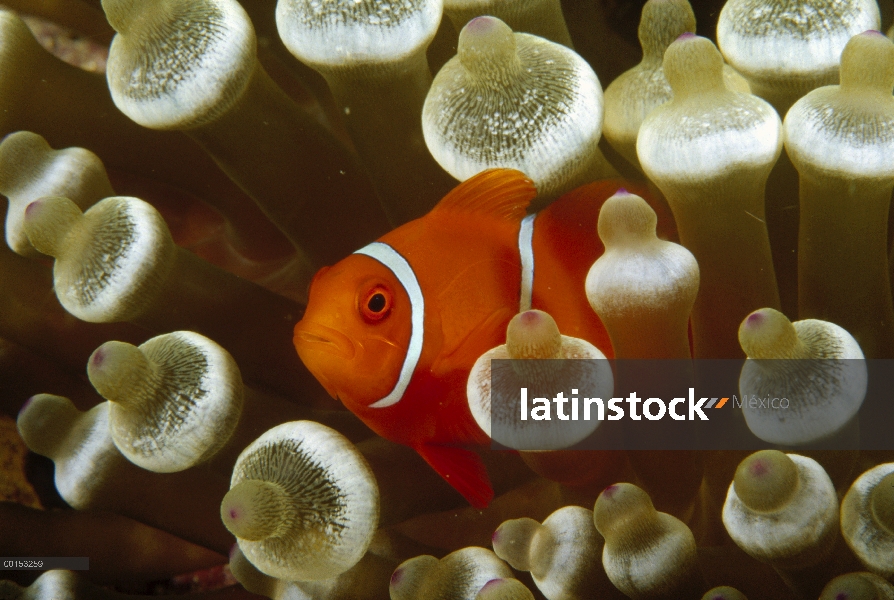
[294, 169, 680, 508]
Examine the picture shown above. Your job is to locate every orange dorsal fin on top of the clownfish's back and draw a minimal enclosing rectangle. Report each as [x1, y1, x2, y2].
[430, 169, 537, 221]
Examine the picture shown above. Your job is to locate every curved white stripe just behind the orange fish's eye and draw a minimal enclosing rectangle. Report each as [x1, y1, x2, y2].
[354, 242, 425, 408]
